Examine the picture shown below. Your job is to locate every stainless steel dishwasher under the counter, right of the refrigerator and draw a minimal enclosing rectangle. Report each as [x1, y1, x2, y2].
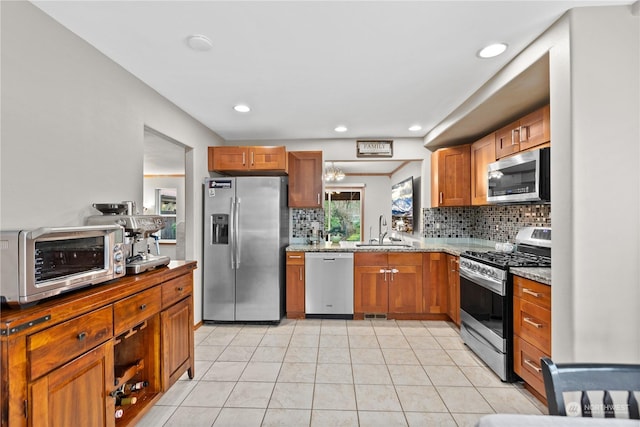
[304, 252, 353, 319]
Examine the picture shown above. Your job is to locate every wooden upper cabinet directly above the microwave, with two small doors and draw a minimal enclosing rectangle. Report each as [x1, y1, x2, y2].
[495, 105, 551, 159]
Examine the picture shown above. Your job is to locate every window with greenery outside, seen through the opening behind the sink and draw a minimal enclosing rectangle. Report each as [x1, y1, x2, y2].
[324, 186, 364, 242]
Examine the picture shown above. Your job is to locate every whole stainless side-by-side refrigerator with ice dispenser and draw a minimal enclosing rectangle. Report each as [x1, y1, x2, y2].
[202, 176, 289, 322]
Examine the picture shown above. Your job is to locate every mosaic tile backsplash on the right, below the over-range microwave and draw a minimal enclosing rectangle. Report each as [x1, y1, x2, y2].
[422, 204, 551, 242]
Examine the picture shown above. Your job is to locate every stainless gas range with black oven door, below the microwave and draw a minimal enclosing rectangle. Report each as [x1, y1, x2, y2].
[460, 227, 551, 382]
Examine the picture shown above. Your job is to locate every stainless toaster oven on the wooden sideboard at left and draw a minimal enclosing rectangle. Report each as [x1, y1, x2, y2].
[0, 224, 126, 305]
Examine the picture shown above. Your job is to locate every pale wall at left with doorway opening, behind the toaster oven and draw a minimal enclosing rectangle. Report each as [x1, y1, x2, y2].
[0, 1, 222, 322]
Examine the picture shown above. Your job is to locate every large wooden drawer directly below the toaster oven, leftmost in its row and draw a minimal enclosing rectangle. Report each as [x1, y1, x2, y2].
[27, 306, 113, 379]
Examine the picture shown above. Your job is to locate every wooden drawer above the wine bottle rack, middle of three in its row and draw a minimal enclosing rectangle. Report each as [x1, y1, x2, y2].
[113, 286, 162, 335]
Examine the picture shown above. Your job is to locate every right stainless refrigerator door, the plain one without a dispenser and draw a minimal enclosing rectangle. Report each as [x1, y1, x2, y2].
[236, 177, 286, 321]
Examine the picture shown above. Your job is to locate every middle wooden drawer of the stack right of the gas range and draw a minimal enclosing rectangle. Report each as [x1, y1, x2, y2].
[513, 297, 551, 354]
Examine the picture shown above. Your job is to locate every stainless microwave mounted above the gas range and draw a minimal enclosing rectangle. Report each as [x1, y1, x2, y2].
[487, 148, 551, 204]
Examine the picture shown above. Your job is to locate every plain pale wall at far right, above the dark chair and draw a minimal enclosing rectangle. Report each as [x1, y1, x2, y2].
[551, 7, 640, 363]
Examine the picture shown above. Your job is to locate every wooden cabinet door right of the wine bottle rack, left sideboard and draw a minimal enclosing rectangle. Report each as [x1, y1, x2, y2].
[160, 296, 194, 391]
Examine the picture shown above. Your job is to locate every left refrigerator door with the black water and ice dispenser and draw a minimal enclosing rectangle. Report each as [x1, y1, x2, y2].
[202, 178, 236, 321]
